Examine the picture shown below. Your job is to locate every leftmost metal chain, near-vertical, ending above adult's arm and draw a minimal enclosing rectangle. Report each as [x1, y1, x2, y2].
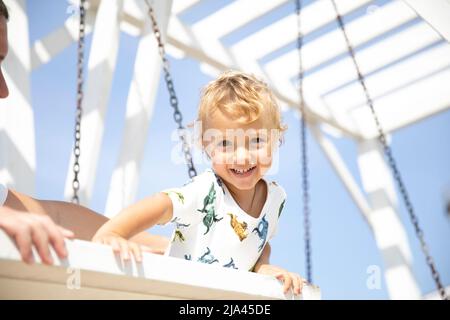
[72, 0, 86, 204]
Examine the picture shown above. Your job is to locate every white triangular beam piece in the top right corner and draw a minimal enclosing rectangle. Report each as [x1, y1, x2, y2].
[403, 0, 450, 42]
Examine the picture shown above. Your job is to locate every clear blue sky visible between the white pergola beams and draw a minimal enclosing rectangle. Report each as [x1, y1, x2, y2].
[28, 0, 450, 299]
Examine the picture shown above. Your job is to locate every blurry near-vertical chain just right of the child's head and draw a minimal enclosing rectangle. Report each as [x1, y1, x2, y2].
[295, 0, 312, 283]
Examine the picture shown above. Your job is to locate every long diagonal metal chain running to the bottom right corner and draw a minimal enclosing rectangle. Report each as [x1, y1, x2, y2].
[331, 0, 448, 300]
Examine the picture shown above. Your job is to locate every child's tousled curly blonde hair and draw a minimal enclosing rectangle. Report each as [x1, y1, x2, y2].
[197, 70, 287, 141]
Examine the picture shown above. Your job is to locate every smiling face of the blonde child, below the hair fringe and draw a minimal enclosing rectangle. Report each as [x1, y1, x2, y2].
[203, 110, 278, 190]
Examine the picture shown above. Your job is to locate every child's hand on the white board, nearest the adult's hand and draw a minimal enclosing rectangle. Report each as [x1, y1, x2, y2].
[92, 234, 147, 263]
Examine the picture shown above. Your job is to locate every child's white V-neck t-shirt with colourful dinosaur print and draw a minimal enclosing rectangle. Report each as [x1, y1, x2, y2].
[162, 168, 286, 270]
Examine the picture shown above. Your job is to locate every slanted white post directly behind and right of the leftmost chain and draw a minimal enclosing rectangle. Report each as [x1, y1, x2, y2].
[65, 0, 123, 205]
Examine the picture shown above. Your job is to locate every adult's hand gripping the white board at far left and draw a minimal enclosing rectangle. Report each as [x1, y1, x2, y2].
[0, 207, 74, 264]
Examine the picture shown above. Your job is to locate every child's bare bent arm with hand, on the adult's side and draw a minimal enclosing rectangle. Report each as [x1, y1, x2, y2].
[92, 193, 173, 262]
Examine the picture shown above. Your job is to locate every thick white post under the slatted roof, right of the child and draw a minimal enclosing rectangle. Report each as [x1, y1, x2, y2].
[358, 140, 421, 299]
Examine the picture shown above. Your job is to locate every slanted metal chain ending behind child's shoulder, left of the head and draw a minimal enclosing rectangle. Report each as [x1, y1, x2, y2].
[145, 0, 197, 179]
